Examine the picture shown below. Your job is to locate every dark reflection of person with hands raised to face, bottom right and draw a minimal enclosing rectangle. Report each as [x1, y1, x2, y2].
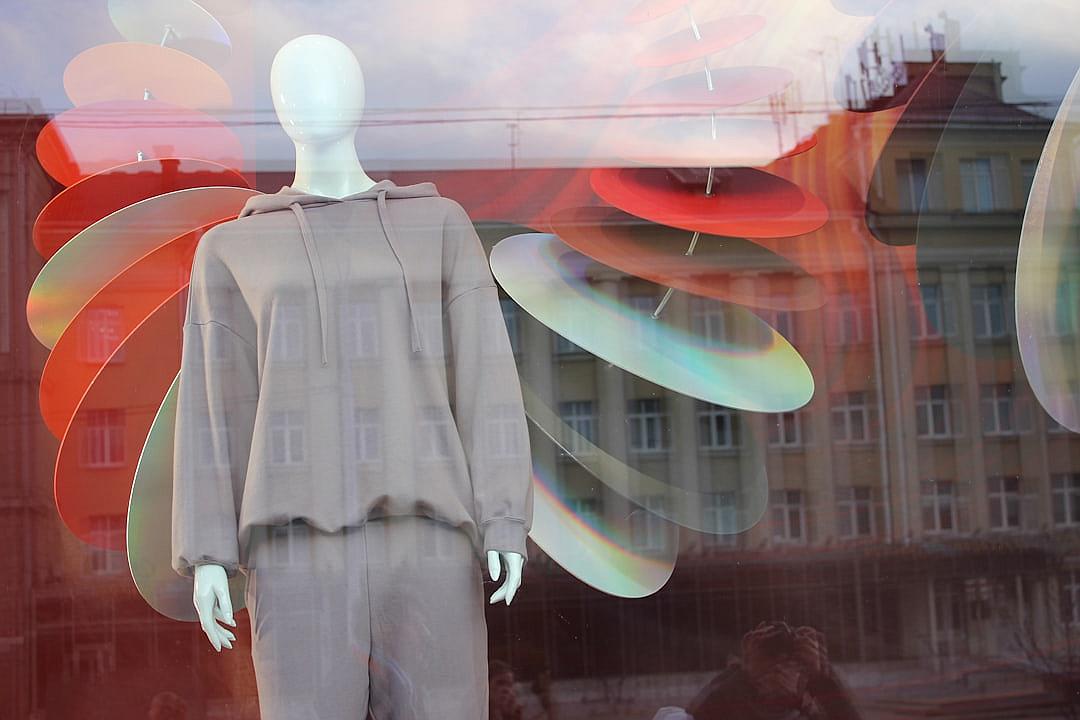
[686, 622, 860, 720]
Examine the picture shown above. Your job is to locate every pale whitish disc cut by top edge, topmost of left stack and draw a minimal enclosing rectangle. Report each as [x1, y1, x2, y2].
[109, 0, 232, 65]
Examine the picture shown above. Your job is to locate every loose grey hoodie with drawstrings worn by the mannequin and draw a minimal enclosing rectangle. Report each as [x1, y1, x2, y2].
[172, 179, 532, 578]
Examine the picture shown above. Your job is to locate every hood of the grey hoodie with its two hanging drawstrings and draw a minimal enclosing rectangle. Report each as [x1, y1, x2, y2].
[240, 178, 438, 365]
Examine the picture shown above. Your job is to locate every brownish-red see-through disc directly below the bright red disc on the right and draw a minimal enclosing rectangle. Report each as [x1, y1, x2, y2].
[551, 207, 825, 310]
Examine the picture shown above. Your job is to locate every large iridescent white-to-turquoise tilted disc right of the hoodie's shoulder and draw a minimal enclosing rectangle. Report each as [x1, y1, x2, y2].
[490, 233, 813, 412]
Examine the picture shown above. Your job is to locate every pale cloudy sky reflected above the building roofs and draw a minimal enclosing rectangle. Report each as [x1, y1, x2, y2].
[0, 0, 1080, 169]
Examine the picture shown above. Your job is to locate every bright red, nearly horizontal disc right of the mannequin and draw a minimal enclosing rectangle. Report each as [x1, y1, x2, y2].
[589, 167, 828, 237]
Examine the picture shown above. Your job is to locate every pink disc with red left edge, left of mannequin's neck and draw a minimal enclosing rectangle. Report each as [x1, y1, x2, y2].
[37, 100, 243, 186]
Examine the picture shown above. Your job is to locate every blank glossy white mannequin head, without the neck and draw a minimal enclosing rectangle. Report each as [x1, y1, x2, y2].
[270, 35, 364, 142]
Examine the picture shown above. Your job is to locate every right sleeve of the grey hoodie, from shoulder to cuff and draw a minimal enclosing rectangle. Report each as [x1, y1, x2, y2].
[443, 202, 532, 558]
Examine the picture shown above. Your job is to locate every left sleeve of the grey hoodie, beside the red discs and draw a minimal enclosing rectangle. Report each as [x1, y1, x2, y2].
[172, 229, 258, 578]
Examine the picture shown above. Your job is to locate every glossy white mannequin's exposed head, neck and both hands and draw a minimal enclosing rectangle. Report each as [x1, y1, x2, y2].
[193, 35, 524, 652]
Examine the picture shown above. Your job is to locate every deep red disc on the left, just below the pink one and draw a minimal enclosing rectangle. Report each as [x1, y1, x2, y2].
[33, 158, 248, 259]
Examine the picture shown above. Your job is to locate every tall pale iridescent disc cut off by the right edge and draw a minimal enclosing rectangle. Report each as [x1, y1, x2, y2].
[1016, 73, 1080, 432]
